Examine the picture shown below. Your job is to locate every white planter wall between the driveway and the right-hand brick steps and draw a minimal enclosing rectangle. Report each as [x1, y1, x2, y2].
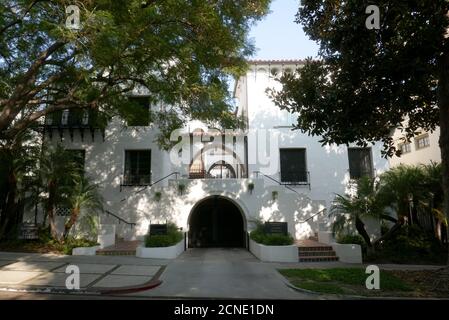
[249, 239, 299, 262]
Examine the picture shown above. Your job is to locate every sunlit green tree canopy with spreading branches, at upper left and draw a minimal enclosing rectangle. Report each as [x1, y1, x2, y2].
[0, 0, 270, 146]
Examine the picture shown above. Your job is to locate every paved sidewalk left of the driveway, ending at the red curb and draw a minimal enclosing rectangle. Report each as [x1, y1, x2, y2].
[0, 252, 167, 294]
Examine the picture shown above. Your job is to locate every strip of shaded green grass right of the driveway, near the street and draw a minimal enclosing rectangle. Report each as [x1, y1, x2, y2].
[279, 268, 413, 296]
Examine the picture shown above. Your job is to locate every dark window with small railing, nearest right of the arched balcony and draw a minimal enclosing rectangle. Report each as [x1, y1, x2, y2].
[280, 149, 308, 184]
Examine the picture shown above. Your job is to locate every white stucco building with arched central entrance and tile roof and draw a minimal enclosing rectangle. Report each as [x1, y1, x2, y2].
[30, 61, 388, 247]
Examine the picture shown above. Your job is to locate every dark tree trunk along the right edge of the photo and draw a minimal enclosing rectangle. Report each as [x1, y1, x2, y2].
[438, 50, 449, 266]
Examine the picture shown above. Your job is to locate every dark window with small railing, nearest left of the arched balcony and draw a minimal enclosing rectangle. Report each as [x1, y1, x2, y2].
[123, 150, 151, 185]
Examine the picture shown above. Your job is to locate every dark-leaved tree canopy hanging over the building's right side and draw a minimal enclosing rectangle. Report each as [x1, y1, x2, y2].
[271, 0, 449, 155]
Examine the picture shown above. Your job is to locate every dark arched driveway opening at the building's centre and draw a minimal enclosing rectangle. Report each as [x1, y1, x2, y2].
[189, 197, 246, 248]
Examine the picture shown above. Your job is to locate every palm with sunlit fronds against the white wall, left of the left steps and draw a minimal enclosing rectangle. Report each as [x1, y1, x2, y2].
[63, 174, 103, 240]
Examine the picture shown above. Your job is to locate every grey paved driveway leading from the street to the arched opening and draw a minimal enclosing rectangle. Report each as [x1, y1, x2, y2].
[128, 249, 316, 299]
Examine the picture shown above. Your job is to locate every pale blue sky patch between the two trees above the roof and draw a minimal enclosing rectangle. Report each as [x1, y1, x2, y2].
[245, 0, 318, 60]
